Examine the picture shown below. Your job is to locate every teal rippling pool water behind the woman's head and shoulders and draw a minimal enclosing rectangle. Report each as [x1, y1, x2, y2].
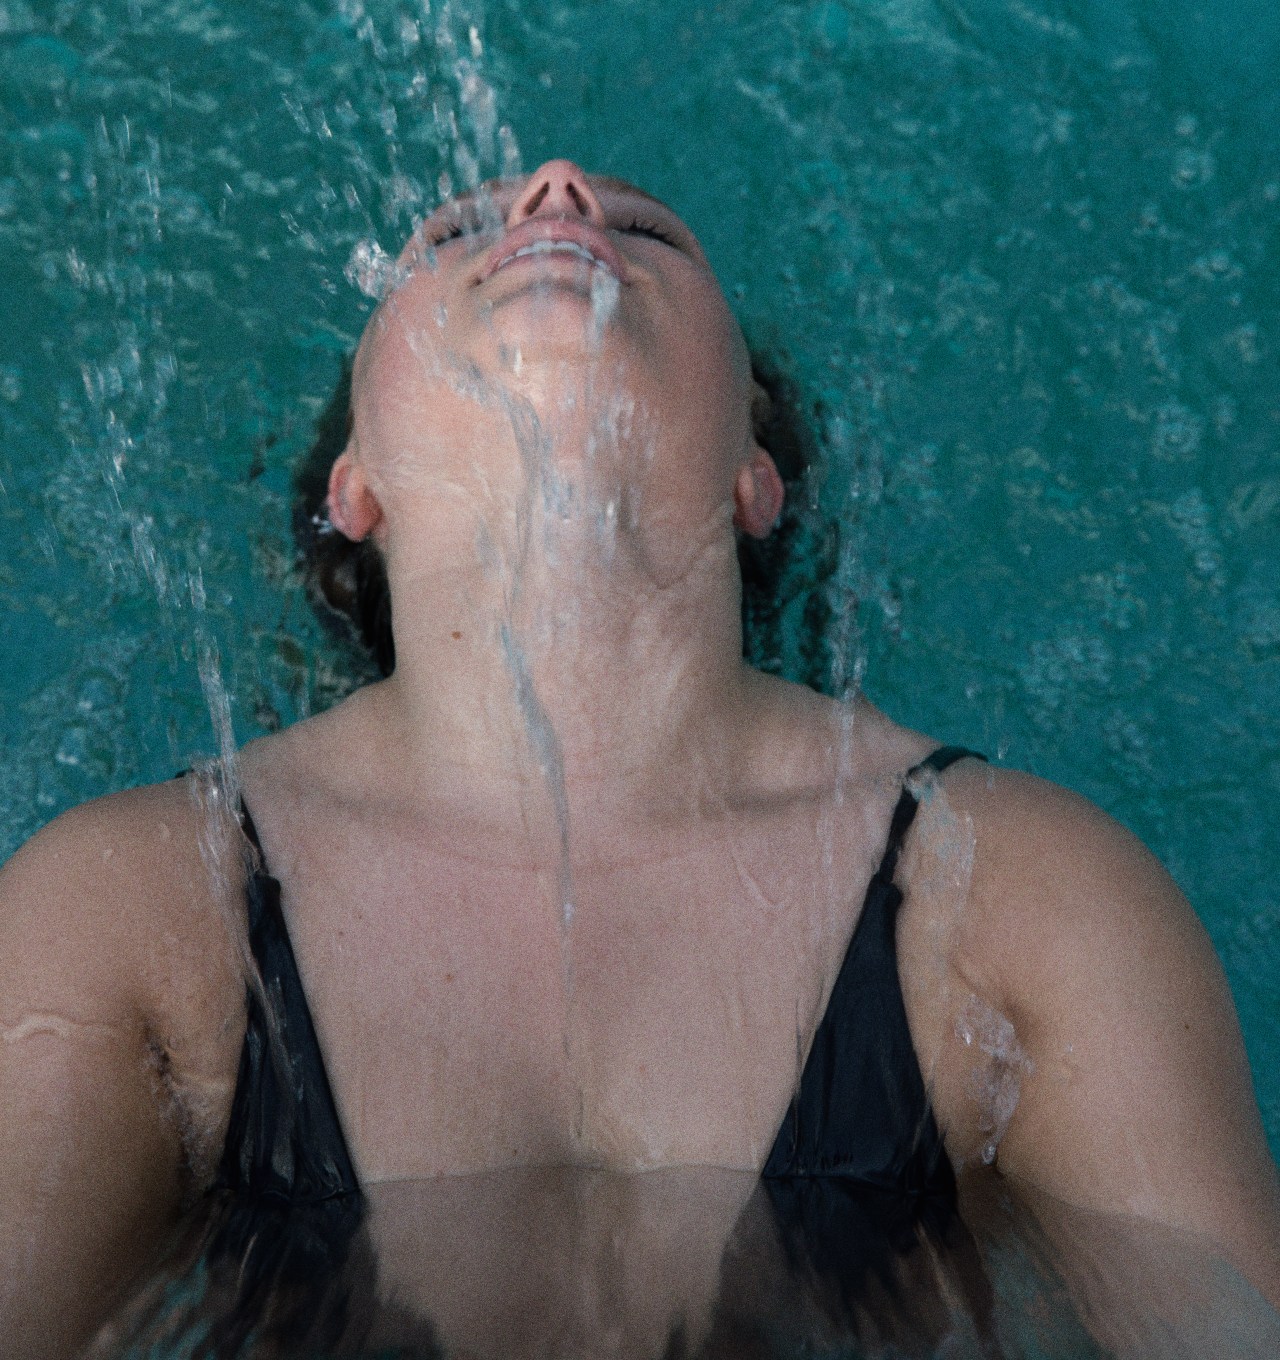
[0, 0, 1280, 1148]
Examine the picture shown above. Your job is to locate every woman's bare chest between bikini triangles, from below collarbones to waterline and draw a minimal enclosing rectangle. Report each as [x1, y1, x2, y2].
[272, 824, 873, 1180]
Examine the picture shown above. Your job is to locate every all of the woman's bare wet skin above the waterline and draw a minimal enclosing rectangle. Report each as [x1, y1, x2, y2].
[0, 160, 1280, 1356]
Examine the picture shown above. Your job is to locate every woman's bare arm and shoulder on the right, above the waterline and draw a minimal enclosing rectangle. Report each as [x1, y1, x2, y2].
[921, 766, 1280, 1307]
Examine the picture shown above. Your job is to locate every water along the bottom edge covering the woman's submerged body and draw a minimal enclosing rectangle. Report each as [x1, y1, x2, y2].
[91, 1167, 1280, 1360]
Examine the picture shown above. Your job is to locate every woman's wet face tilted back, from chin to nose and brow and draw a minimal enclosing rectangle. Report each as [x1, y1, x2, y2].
[340, 160, 772, 557]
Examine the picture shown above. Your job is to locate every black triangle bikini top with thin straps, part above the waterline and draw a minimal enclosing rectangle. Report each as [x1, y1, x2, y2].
[216, 747, 985, 1205]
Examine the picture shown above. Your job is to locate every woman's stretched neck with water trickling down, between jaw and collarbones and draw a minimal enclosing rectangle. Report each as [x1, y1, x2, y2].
[369, 497, 752, 812]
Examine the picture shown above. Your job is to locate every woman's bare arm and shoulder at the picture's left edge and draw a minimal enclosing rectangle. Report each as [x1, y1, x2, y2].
[0, 782, 243, 1357]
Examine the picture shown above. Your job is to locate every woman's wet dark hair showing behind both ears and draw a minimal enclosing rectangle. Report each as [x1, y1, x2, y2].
[294, 358, 815, 676]
